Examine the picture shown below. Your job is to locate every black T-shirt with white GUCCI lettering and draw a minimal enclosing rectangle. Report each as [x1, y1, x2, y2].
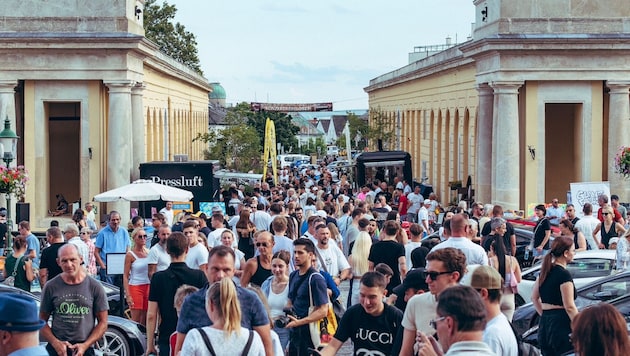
[335, 304, 403, 355]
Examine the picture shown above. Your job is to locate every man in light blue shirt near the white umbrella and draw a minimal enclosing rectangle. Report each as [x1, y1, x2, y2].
[94, 211, 131, 287]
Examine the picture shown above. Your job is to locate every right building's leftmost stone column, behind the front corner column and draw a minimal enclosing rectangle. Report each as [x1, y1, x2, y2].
[475, 83, 494, 203]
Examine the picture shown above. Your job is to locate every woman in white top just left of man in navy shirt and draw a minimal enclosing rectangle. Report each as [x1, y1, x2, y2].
[261, 250, 291, 350]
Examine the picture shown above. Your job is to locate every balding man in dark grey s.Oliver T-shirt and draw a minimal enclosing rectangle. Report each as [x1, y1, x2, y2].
[39, 244, 109, 356]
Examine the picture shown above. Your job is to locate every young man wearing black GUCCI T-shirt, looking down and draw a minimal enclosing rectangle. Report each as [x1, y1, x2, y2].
[321, 272, 403, 355]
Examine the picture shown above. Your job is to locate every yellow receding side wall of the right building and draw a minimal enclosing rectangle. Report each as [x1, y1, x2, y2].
[369, 64, 478, 203]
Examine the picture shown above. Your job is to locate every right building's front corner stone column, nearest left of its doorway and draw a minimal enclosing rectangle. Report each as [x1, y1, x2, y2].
[489, 81, 523, 210]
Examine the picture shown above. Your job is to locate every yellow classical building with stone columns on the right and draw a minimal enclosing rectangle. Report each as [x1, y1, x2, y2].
[365, 0, 630, 209]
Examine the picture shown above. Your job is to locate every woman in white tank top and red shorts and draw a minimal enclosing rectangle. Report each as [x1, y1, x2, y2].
[123, 227, 151, 325]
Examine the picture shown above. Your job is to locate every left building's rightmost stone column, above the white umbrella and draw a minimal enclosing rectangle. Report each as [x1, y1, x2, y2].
[131, 83, 147, 181]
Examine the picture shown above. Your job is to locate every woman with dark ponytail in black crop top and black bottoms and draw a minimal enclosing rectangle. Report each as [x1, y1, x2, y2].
[532, 236, 578, 355]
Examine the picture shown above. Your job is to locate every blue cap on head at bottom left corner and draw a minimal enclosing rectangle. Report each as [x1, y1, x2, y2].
[0, 293, 45, 332]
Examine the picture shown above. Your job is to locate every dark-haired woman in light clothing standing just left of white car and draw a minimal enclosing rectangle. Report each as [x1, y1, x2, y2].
[488, 218, 521, 322]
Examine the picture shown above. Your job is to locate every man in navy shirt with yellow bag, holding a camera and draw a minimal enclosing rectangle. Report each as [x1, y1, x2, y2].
[286, 238, 329, 355]
